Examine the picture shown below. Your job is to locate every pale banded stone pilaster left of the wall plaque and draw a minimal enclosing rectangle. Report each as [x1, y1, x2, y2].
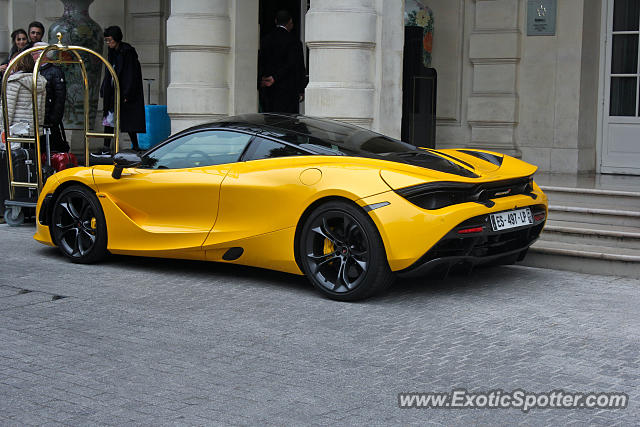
[467, 0, 522, 157]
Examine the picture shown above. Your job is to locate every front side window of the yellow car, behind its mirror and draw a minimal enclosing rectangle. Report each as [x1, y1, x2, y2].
[140, 130, 252, 169]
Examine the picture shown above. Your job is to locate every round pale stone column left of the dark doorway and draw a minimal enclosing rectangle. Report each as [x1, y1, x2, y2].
[167, 0, 231, 133]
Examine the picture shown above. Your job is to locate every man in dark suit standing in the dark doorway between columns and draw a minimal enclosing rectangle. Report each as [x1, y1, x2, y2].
[258, 10, 308, 113]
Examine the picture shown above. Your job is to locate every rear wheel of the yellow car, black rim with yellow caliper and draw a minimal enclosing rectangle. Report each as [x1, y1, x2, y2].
[298, 201, 394, 301]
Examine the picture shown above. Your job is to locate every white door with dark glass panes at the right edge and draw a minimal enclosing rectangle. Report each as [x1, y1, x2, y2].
[601, 0, 640, 175]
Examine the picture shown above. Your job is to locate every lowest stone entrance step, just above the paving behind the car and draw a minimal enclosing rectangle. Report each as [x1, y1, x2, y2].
[522, 238, 640, 279]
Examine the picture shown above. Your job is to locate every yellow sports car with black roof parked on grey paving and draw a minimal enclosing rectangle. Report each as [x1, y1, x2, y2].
[34, 114, 547, 300]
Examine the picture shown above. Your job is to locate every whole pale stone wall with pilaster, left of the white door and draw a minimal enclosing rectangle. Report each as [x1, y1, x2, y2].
[436, 0, 601, 173]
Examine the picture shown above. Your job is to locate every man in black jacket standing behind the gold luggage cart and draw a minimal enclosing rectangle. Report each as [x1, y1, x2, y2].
[32, 42, 69, 153]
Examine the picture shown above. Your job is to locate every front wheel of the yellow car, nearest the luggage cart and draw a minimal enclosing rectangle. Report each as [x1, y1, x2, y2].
[51, 185, 107, 264]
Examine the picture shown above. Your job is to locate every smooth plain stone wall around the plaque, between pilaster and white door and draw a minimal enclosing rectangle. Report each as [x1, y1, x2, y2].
[517, 0, 601, 173]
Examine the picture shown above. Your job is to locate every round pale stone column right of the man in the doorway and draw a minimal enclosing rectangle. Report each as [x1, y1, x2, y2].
[305, 0, 378, 128]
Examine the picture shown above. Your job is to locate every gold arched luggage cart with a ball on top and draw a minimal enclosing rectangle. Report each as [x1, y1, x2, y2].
[2, 33, 120, 225]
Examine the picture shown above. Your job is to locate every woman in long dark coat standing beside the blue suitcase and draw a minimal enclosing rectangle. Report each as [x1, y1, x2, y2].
[100, 26, 146, 154]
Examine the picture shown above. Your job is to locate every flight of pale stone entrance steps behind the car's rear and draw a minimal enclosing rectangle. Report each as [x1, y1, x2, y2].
[523, 176, 640, 278]
